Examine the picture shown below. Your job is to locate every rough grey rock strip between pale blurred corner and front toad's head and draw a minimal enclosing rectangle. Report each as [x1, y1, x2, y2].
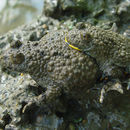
[0, 17, 59, 51]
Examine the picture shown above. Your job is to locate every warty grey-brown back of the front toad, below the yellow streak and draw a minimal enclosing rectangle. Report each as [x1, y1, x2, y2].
[24, 31, 98, 86]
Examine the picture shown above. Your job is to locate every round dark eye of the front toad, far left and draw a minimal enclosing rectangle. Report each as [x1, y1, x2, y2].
[10, 53, 25, 64]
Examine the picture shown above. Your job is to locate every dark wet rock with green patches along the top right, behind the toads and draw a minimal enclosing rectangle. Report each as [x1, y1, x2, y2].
[43, 0, 130, 31]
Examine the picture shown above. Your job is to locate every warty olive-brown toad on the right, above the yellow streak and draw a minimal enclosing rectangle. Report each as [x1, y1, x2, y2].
[68, 24, 130, 67]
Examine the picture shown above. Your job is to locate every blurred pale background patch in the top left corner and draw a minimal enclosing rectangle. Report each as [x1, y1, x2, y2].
[0, 0, 43, 35]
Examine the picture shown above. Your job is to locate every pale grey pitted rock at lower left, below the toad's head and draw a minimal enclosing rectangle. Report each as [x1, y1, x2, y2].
[0, 70, 36, 125]
